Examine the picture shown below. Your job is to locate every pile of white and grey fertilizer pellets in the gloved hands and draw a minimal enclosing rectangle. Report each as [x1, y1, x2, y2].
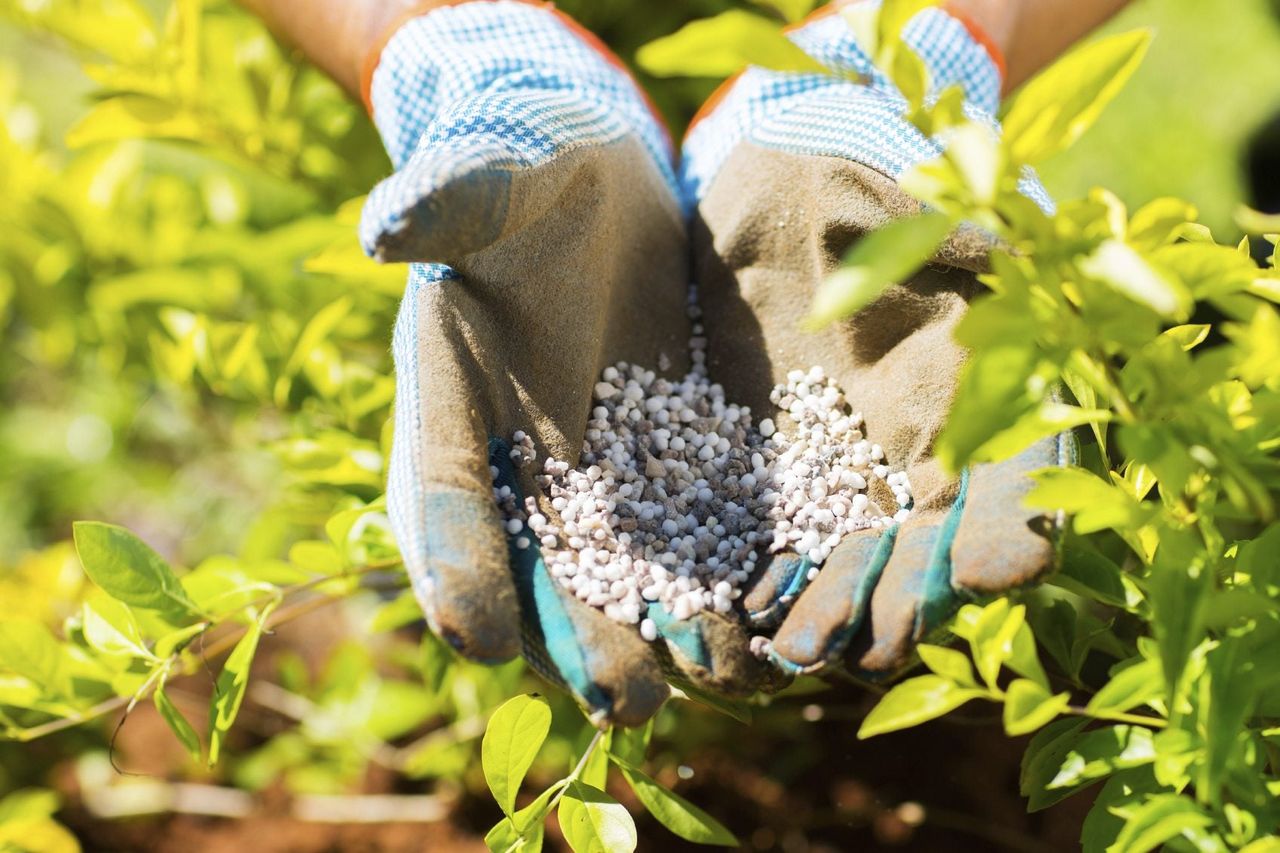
[492, 290, 911, 640]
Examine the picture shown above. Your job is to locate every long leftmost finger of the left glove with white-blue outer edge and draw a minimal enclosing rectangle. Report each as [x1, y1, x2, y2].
[387, 266, 520, 662]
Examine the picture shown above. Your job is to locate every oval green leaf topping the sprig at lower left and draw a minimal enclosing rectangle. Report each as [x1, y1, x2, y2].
[73, 521, 196, 625]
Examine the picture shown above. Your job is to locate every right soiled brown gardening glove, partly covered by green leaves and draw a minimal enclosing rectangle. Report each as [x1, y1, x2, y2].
[682, 0, 1069, 679]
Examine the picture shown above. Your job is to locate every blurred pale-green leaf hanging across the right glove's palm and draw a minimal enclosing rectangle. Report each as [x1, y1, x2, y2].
[805, 214, 951, 328]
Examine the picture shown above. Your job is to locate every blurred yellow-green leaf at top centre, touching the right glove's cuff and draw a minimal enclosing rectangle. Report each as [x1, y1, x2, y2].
[636, 9, 831, 77]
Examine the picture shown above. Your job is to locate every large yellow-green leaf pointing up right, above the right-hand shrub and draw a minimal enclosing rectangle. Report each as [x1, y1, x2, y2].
[1002, 29, 1151, 163]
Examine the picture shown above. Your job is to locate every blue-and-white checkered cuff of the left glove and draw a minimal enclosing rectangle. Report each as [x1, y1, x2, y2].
[370, 0, 672, 173]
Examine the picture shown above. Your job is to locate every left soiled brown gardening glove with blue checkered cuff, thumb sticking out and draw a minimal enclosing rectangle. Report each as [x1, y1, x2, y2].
[360, 0, 765, 725]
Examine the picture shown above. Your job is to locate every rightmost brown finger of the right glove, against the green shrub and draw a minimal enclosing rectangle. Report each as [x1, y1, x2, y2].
[951, 433, 1075, 597]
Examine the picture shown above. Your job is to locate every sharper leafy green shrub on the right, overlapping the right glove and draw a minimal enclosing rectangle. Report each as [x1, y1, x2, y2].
[815, 3, 1280, 850]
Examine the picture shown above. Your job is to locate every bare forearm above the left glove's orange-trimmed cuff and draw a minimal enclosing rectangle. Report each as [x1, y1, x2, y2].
[232, 0, 427, 97]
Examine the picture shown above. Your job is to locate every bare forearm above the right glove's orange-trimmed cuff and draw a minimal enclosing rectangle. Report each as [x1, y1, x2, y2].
[948, 0, 1130, 92]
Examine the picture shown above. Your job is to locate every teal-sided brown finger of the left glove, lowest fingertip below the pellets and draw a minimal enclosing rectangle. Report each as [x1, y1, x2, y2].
[489, 438, 671, 726]
